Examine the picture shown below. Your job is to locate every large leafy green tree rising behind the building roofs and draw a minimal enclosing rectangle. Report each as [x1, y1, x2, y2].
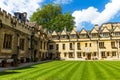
[30, 4, 74, 32]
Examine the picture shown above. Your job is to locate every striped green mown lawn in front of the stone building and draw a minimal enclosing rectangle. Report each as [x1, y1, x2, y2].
[0, 61, 120, 80]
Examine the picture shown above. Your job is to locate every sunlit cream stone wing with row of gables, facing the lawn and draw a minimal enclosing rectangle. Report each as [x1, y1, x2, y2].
[49, 23, 120, 60]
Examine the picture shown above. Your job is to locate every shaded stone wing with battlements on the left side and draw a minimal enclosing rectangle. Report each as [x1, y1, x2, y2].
[0, 9, 48, 61]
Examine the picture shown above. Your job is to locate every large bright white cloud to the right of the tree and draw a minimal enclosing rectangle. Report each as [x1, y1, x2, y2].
[72, 0, 120, 29]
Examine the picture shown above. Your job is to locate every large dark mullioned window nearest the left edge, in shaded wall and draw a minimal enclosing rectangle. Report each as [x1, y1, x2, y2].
[3, 34, 12, 49]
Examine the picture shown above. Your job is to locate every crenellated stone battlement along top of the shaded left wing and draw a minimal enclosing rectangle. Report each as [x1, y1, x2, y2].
[0, 8, 32, 34]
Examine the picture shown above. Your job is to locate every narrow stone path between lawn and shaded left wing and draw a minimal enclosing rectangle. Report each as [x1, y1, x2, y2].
[0, 60, 51, 72]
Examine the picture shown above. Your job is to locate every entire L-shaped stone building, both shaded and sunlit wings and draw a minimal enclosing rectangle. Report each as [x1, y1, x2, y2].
[0, 9, 120, 60]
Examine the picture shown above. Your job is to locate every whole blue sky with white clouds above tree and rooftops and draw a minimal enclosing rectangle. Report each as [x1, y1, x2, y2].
[0, 0, 120, 31]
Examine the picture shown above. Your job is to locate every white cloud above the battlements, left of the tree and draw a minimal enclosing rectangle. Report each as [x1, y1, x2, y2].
[0, 0, 43, 17]
